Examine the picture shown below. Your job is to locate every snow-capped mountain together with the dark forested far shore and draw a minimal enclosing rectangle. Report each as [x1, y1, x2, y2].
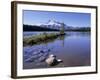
[23, 20, 90, 31]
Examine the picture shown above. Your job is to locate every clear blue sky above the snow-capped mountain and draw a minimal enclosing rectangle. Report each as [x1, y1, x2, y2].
[23, 10, 91, 27]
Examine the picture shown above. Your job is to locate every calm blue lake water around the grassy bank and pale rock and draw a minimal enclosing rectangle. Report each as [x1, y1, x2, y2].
[23, 32, 91, 69]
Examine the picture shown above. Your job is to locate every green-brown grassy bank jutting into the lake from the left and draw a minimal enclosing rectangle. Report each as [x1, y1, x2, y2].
[23, 33, 64, 46]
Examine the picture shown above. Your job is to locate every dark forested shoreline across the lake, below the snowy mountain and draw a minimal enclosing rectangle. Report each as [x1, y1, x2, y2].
[23, 24, 91, 31]
